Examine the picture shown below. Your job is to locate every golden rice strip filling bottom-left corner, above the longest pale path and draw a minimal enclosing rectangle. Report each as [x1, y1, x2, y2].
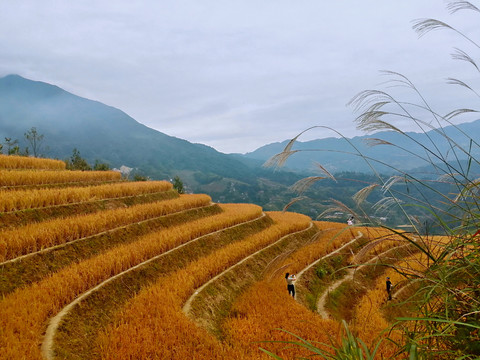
[0, 205, 261, 360]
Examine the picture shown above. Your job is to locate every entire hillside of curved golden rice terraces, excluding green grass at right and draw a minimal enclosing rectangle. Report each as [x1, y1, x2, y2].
[0, 156, 432, 360]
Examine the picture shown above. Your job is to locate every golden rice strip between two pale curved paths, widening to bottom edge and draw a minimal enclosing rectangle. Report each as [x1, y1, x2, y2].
[99, 212, 310, 359]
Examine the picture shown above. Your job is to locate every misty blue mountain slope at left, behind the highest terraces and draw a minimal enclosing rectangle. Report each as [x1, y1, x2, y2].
[0, 75, 252, 181]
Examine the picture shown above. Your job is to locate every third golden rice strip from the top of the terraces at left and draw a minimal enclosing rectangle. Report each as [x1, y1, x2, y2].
[0, 181, 173, 212]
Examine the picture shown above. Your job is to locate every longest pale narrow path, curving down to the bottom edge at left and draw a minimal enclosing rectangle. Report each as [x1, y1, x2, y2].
[41, 212, 267, 360]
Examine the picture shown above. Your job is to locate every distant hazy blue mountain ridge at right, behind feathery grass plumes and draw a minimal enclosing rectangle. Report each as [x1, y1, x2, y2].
[244, 120, 480, 173]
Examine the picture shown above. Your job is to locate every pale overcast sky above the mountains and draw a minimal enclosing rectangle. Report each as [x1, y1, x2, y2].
[0, 0, 480, 153]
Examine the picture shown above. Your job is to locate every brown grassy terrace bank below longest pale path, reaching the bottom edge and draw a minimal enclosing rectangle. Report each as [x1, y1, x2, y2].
[42, 213, 272, 359]
